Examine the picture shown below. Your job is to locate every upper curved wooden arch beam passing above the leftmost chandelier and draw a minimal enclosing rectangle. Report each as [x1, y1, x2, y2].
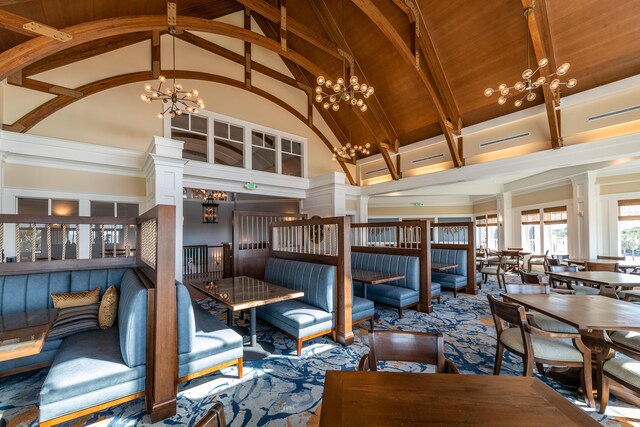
[0, 15, 330, 80]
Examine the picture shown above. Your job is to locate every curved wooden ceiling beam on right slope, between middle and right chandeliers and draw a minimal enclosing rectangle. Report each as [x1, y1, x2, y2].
[352, 0, 464, 167]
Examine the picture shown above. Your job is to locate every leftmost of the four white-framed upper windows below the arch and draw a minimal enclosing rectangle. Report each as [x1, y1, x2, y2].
[171, 114, 209, 162]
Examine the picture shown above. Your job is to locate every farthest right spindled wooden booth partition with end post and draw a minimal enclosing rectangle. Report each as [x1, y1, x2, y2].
[431, 222, 477, 295]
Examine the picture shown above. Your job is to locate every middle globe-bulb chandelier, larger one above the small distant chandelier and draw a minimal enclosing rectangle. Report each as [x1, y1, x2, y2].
[315, 76, 374, 113]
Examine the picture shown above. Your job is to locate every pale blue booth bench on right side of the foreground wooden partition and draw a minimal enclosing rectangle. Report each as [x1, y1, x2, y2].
[176, 283, 243, 382]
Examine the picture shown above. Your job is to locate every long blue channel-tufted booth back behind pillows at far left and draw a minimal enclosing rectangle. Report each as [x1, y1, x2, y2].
[0, 268, 127, 315]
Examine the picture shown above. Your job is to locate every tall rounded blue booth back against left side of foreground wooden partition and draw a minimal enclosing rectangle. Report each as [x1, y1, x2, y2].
[118, 269, 147, 368]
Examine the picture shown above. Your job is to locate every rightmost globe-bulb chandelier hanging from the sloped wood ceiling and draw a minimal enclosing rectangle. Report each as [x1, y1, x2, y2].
[484, 1, 578, 107]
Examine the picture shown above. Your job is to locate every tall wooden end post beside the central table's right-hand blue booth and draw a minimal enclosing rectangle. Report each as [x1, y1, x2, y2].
[335, 216, 353, 345]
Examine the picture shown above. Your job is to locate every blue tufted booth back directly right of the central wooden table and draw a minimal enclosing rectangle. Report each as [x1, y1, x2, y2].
[264, 258, 336, 313]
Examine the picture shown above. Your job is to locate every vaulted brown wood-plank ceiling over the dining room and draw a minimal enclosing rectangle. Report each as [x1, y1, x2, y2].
[0, 0, 640, 182]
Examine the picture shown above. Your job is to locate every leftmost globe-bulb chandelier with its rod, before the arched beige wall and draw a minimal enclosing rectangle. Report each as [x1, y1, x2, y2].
[140, 27, 204, 119]
